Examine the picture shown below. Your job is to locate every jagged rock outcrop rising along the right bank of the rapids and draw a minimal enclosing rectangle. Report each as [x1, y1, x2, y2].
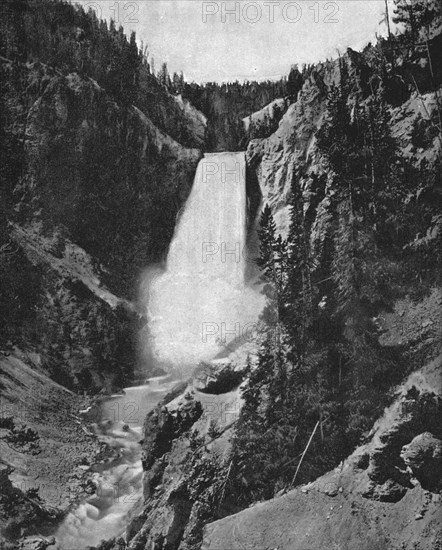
[95, 383, 241, 550]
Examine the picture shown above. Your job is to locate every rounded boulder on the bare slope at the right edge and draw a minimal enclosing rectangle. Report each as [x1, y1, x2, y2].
[401, 432, 442, 490]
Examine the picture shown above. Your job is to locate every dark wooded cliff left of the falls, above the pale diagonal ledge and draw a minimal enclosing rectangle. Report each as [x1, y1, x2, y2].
[12, 60, 203, 294]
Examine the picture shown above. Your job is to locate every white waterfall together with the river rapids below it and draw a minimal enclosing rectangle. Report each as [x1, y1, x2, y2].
[55, 153, 264, 550]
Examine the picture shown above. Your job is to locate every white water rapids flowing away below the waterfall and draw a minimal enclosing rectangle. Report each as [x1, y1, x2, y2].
[55, 378, 176, 550]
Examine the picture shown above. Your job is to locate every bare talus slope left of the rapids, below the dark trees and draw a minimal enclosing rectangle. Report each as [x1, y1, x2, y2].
[0, 349, 108, 538]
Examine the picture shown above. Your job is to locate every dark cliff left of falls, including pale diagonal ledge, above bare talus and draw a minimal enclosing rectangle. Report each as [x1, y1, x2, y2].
[2, 59, 205, 391]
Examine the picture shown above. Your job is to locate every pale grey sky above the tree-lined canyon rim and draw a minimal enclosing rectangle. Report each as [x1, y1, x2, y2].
[78, 0, 393, 82]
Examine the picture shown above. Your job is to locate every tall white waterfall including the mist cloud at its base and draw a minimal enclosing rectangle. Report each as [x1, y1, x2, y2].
[142, 153, 264, 376]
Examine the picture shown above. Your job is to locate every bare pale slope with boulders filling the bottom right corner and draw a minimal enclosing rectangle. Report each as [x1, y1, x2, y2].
[202, 357, 442, 550]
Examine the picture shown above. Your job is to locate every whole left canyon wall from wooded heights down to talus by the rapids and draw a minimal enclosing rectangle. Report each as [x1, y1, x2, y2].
[0, 10, 206, 548]
